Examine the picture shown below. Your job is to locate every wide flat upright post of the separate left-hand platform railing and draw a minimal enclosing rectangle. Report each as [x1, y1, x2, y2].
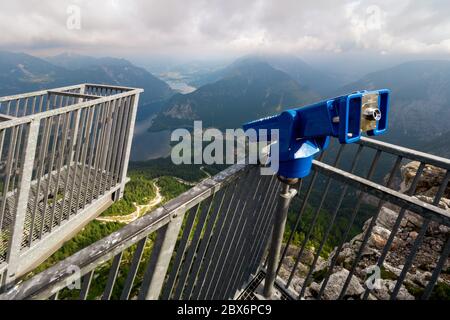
[5, 120, 40, 286]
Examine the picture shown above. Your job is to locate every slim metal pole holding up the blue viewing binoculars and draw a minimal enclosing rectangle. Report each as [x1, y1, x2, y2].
[263, 177, 298, 299]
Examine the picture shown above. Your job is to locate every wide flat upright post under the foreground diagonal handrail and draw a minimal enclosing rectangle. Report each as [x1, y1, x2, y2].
[139, 215, 184, 300]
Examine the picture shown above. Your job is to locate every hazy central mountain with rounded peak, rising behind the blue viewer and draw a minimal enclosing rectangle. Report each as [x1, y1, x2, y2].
[151, 60, 319, 131]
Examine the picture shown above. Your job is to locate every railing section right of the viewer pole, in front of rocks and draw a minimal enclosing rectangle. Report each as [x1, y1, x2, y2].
[277, 138, 450, 300]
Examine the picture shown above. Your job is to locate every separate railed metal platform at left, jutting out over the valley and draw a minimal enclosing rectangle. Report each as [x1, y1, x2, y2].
[0, 84, 142, 285]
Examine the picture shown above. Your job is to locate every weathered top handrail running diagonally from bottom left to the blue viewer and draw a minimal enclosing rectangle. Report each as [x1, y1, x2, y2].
[0, 165, 250, 300]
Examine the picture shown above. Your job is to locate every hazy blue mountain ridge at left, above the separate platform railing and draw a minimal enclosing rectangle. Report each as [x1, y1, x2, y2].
[0, 52, 173, 105]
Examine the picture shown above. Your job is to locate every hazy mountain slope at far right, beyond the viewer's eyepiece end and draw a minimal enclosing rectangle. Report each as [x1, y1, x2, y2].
[333, 61, 450, 151]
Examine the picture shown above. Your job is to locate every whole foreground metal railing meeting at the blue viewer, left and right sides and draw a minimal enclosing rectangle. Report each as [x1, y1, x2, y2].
[0, 138, 450, 300]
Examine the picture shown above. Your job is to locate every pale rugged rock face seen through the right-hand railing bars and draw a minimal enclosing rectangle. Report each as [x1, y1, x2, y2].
[282, 162, 450, 300]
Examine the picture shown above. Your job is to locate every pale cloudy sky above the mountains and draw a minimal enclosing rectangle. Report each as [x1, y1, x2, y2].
[0, 0, 450, 60]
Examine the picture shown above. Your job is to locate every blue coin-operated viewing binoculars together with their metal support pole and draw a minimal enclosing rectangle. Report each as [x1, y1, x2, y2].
[243, 89, 390, 298]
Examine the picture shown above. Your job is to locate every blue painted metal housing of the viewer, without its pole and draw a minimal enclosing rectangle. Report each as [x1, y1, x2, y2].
[243, 89, 390, 178]
